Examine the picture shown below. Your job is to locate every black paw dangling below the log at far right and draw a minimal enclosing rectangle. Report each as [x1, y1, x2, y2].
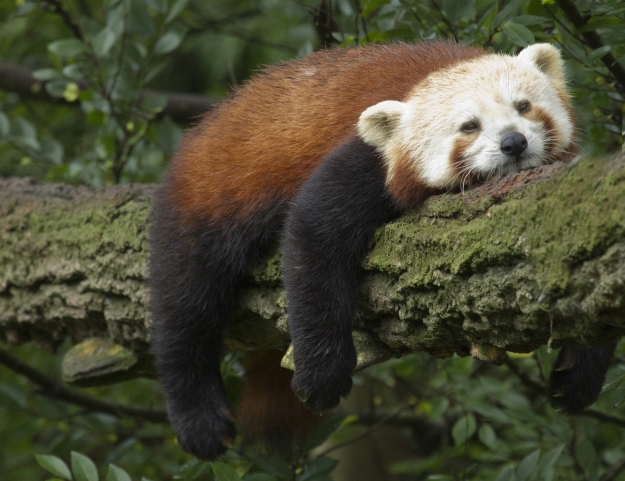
[549, 343, 616, 415]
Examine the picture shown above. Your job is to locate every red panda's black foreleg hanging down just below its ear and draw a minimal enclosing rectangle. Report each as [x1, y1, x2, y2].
[283, 138, 400, 410]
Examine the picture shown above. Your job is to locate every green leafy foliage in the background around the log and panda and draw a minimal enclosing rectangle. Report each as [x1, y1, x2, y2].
[0, 0, 625, 481]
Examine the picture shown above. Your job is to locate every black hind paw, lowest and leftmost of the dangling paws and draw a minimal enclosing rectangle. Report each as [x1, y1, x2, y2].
[170, 407, 236, 461]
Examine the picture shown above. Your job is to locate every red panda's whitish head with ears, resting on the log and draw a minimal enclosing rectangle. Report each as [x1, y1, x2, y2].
[358, 44, 574, 187]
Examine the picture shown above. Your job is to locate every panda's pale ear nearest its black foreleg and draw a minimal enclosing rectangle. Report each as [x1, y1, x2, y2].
[356, 100, 407, 149]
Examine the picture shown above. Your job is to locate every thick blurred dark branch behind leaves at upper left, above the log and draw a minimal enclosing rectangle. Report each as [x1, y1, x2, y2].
[0, 61, 220, 123]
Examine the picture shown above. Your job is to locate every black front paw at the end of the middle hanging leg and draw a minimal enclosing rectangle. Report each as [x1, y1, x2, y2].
[291, 366, 353, 411]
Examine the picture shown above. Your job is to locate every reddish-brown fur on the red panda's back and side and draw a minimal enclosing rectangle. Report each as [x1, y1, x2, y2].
[163, 43, 485, 223]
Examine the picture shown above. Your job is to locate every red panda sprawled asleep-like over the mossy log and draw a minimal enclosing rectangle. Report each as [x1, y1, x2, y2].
[150, 42, 613, 459]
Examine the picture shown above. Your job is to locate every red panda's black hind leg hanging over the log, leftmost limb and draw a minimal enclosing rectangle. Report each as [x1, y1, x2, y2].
[150, 189, 284, 460]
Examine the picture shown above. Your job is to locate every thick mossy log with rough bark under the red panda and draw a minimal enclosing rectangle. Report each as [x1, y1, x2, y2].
[0, 155, 625, 382]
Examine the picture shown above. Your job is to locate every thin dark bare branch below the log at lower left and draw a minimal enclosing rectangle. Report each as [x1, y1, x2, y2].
[0, 349, 168, 423]
